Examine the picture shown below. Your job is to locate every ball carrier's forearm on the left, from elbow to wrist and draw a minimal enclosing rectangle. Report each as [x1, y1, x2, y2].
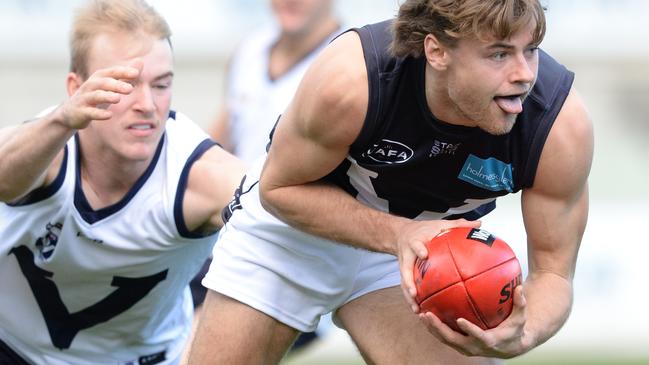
[261, 182, 409, 255]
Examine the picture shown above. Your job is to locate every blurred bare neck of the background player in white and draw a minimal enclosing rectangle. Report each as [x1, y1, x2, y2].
[269, 17, 340, 79]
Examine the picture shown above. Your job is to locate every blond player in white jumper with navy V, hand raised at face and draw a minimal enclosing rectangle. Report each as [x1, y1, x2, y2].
[0, 0, 243, 365]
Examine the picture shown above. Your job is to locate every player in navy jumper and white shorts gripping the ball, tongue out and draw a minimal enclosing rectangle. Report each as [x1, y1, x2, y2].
[190, 0, 593, 364]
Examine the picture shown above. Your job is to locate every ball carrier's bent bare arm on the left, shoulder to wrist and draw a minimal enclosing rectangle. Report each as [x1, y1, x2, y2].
[260, 32, 402, 254]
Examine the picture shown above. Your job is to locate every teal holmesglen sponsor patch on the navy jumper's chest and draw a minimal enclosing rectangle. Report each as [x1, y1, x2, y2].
[458, 155, 514, 193]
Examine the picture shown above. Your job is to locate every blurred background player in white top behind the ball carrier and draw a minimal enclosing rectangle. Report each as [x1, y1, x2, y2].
[192, 0, 341, 349]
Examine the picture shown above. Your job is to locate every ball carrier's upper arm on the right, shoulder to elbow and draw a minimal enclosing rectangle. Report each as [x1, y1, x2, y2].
[533, 88, 594, 196]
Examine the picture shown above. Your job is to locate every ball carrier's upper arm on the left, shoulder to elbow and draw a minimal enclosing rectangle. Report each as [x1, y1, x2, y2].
[261, 33, 368, 191]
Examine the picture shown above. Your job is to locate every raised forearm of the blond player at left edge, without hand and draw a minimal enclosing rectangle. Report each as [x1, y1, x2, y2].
[0, 106, 74, 201]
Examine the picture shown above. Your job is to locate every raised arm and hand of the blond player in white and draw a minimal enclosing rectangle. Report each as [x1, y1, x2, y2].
[0, 65, 141, 202]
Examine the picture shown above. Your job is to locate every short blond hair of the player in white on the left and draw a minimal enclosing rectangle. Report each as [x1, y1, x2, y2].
[70, 0, 171, 78]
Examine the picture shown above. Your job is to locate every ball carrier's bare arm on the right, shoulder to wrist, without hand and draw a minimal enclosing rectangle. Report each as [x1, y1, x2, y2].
[522, 85, 593, 346]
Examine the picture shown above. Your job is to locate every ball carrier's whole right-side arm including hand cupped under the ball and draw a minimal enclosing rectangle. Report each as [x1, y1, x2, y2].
[421, 86, 593, 358]
